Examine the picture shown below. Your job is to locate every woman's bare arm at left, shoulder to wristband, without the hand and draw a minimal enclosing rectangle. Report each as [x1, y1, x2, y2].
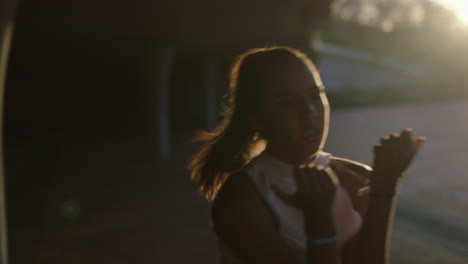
[212, 173, 339, 264]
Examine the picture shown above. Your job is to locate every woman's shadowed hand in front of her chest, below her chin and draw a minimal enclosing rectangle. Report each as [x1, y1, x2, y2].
[272, 166, 338, 237]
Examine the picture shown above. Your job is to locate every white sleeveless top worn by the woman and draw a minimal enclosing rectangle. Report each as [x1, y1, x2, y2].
[218, 151, 362, 264]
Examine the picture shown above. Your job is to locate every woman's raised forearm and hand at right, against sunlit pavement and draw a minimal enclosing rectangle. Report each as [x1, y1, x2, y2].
[345, 130, 423, 264]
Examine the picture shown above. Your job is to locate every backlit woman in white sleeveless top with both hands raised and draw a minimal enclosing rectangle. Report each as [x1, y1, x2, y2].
[191, 47, 423, 264]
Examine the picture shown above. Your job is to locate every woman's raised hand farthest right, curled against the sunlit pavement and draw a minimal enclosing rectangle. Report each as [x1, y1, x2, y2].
[372, 129, 425, 192]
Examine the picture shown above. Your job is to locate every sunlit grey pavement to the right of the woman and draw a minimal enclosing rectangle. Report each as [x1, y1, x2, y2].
[326, 101, 468, 264]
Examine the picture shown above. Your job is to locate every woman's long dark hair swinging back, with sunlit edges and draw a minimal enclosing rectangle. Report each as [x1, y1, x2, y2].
[189, 46, 318, 200]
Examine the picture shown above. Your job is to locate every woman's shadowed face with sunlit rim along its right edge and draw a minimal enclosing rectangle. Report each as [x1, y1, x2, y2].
[255, 59, 330, 164]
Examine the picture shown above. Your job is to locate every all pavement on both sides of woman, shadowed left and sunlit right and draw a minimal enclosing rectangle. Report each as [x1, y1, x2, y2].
[6, 102, 468, 264]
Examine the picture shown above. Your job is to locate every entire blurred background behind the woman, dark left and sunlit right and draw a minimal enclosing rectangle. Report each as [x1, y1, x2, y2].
[0, 0, 468, 264]
